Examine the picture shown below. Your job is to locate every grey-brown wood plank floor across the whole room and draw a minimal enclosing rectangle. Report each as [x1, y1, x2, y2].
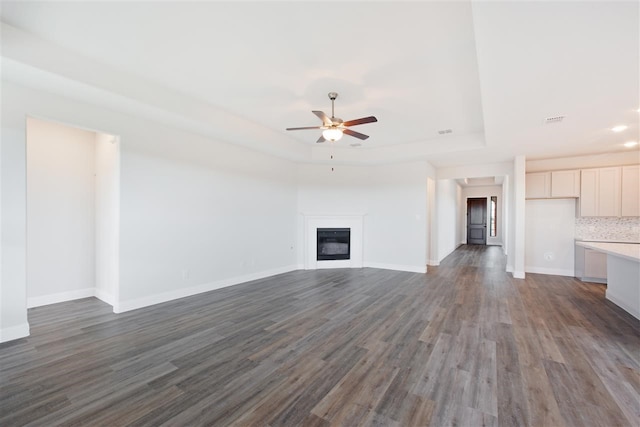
[0, 246, 640, 426]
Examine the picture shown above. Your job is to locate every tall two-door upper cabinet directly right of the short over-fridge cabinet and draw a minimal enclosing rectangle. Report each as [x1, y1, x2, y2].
[580, 167, 620, 216]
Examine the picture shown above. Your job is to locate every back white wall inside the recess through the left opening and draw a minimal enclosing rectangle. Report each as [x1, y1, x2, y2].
[27, 118, 95, 307]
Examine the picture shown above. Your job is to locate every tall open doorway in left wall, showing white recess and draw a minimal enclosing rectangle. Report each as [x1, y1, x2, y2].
[26, 117, 120, 309]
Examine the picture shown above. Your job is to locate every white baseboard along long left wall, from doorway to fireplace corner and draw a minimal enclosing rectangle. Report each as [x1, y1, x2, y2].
[113, 264, 298, 313]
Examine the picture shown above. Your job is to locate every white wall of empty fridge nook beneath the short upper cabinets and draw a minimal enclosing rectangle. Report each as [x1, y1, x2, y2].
[525, 199, 576, 276]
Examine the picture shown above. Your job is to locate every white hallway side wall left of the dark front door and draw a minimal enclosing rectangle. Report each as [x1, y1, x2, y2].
[436, 179, 462, 263]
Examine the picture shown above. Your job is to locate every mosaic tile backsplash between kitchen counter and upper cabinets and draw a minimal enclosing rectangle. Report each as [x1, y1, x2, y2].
[576, 216, 640, 243]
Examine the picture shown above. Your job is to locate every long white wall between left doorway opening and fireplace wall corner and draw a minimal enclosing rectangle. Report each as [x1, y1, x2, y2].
[120, 135, 296, 308]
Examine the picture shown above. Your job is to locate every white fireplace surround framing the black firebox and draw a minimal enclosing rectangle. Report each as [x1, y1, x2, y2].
[302, 213, 365, 270]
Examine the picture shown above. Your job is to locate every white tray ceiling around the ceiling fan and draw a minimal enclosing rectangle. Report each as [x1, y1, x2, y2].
[1, 1, 640, 166]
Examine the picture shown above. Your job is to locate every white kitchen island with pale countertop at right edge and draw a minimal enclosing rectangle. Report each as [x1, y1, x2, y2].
[576, 242, 640, 319]
